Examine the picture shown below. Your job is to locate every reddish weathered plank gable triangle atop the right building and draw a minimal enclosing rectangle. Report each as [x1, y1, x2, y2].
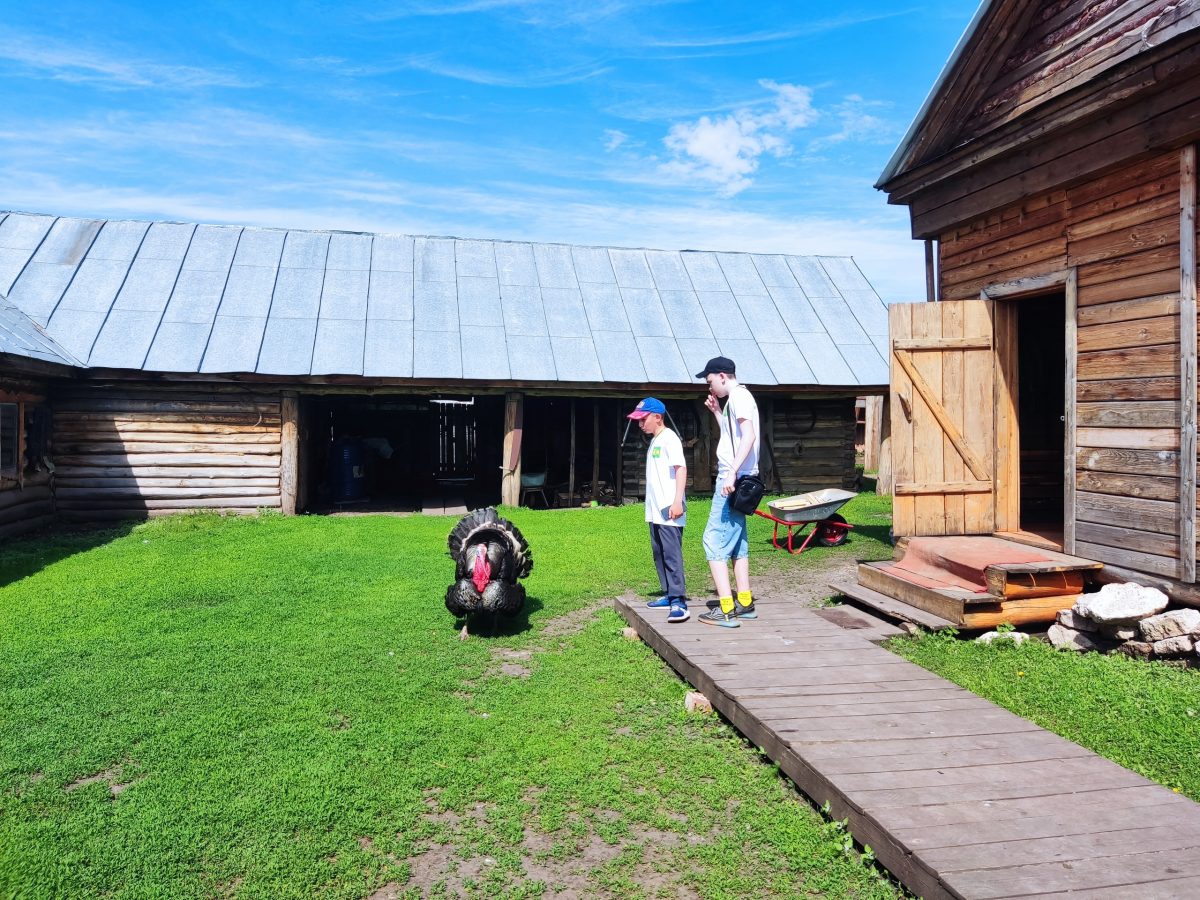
[962, 0, 1177, 134]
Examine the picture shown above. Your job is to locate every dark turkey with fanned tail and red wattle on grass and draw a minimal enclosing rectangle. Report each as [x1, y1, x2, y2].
[446, 506, 533, 637]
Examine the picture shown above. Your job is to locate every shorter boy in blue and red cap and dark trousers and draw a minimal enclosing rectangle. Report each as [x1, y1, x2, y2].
[628, 397, 690, 622]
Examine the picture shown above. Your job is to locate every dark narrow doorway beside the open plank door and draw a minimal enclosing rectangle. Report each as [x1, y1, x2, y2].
[1008, 290, 1067, 547]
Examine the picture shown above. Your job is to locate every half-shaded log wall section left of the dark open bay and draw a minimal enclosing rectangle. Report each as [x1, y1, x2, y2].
[53, 388, 281, 520]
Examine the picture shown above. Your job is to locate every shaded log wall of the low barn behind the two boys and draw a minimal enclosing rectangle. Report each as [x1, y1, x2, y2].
[623, 394, 858, 498]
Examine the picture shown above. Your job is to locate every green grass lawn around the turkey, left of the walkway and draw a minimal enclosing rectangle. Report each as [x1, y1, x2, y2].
[0, 496, 896, 900]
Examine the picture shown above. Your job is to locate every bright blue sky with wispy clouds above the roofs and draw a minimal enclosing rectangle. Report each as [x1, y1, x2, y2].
[0, 0, 973, 301]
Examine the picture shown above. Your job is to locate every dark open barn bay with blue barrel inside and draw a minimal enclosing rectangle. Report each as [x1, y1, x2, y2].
[299, 395, 504, 515]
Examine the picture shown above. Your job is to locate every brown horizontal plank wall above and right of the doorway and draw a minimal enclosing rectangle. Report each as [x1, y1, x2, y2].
[940, 152, 1180, 577]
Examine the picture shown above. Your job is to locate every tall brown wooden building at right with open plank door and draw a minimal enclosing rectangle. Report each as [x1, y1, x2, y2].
[877, 0, 1200, 604]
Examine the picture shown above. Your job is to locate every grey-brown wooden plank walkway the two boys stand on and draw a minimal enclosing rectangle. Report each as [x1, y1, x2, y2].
[616, 598, 1200, 900]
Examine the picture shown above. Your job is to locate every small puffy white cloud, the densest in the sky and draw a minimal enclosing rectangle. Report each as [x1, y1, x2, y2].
[660, 80, 818, 197]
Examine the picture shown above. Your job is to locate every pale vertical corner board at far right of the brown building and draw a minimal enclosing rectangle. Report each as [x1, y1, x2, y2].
[1178, 144, 1196, 583]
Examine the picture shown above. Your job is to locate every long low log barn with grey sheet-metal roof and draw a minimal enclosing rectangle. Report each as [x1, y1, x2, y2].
[0, 212, 887, 536]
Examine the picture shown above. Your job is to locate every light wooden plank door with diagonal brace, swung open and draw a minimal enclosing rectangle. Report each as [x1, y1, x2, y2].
[889, 300, 996, 536]
